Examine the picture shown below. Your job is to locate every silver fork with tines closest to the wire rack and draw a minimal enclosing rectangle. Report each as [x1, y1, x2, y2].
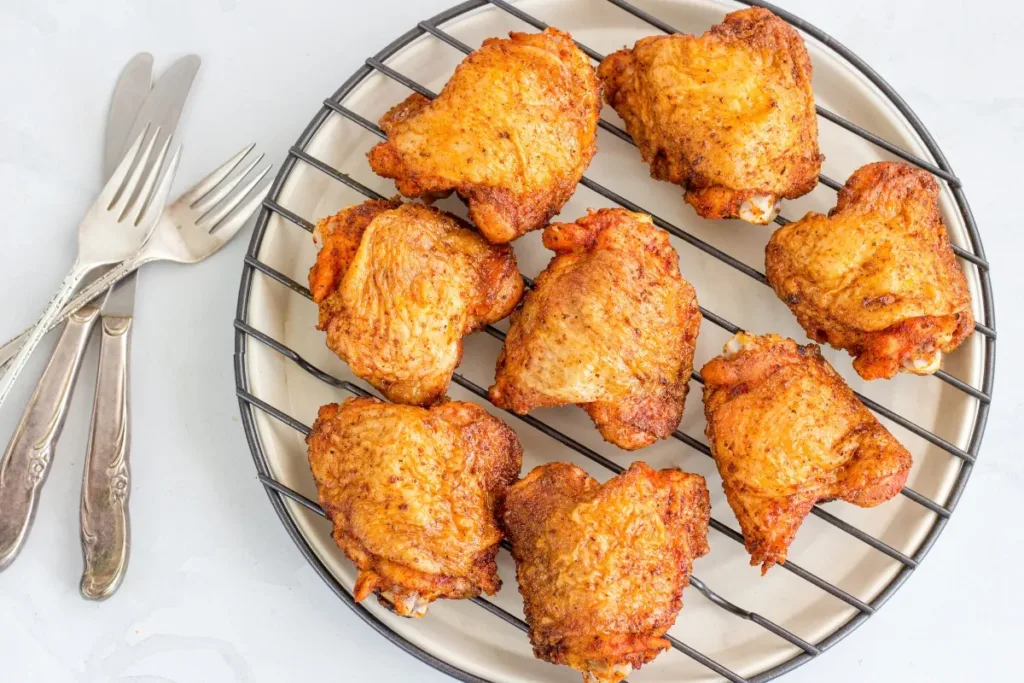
[0, 143, 271, 374]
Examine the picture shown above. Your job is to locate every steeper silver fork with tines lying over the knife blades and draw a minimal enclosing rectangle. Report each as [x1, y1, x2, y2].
[0, 129, 181, 411]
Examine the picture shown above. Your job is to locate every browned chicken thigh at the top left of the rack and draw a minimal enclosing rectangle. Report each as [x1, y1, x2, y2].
[370, 29, 601, 244]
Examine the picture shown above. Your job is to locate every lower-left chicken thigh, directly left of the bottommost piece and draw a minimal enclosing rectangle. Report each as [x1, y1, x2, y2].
[306, 398, 522, 616]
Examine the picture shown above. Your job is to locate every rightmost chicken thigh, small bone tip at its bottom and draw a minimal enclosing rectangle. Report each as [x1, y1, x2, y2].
[765, 162, 974, 380]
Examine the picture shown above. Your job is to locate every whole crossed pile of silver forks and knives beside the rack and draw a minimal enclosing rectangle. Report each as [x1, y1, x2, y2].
[0, 53, 270, 600]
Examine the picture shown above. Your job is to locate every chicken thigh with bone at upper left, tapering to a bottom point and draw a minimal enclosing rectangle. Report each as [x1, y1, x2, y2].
[700, 333, 910, 573]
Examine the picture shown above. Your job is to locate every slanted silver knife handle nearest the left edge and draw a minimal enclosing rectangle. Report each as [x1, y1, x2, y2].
[0, 306, 99, 569]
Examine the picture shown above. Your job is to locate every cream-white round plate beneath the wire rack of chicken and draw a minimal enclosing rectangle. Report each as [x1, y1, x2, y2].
[237, 0, 984, 682]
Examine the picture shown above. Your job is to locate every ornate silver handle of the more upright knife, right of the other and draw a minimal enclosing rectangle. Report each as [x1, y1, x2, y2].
[81, 315, 132, 600]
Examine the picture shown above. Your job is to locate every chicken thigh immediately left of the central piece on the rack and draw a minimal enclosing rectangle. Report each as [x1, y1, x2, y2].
[309, 200, 523, 405]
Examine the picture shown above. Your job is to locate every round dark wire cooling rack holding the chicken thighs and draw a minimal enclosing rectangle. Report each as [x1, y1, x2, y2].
[234, 0, 995, 682]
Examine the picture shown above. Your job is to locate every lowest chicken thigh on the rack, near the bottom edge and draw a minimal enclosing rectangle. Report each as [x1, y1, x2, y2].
[503, 462, 711, 683]
